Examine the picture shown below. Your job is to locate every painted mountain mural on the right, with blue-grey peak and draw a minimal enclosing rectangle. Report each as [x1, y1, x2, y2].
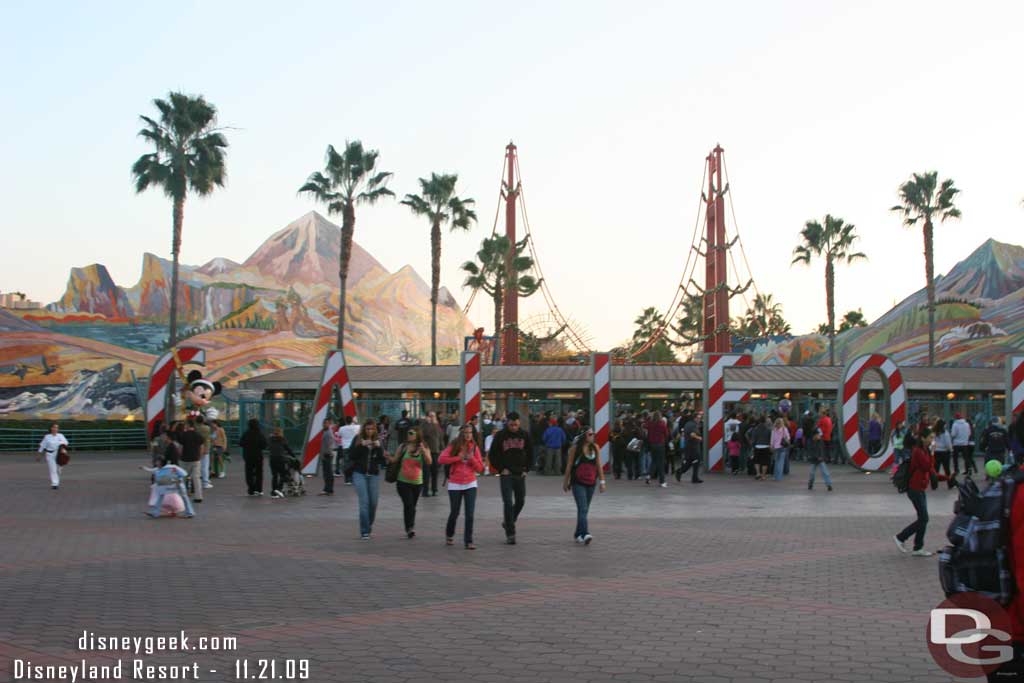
[754, 240, 1024, 366]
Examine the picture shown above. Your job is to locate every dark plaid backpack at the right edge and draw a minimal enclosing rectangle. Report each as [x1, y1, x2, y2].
[939, 471, 1024, 605]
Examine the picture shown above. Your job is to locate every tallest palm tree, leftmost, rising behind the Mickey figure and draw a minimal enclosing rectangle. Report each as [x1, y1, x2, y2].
[131, 92, 227, 356]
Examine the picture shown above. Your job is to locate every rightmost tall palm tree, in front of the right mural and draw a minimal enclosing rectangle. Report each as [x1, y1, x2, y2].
[890, 171, 961, 366]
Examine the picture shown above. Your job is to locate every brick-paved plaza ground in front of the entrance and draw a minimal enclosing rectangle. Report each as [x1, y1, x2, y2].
[0, 453, 966, 683]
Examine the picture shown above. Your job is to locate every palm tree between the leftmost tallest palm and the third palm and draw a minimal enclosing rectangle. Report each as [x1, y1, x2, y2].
[299, 140, 394, 349]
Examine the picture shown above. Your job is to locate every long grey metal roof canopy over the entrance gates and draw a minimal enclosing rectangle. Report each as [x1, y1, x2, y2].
[240, 365, 1006, 392]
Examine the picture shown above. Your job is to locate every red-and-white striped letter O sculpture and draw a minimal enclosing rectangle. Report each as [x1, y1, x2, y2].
[834, 353, 906, 471]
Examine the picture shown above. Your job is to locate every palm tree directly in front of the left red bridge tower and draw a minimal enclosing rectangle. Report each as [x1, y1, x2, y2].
[462, 234, 541, 360]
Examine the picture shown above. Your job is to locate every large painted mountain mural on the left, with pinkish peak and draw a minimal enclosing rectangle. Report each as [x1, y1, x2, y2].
[0, 212, 473, 419]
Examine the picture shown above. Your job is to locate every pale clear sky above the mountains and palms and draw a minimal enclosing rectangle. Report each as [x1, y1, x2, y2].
[0, 0, 1024, 348]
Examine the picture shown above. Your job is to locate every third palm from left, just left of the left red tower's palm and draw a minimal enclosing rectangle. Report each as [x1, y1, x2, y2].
[401, 173, 476, 366]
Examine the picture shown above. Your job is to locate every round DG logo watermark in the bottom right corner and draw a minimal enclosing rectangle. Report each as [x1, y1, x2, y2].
[926, 593, 1018, 680]
